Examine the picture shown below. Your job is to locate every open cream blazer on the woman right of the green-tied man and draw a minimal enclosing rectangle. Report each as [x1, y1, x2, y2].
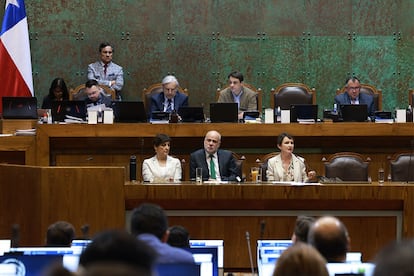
[266, 154, 308, 182]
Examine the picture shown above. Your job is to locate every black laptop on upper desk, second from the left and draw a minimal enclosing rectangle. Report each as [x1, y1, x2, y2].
[52, 101, 86, 122]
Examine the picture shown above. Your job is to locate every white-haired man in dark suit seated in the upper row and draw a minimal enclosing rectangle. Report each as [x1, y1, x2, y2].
[149, 75, 188, 117]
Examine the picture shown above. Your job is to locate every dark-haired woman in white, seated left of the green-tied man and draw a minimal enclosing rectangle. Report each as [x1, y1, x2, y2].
[142, 134, 181, 183]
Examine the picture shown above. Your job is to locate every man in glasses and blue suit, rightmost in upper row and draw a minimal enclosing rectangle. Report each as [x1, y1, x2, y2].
[335, 76, 375, 117]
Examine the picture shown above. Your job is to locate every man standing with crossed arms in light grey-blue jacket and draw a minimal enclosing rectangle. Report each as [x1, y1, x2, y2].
[88, 42, 124, 101]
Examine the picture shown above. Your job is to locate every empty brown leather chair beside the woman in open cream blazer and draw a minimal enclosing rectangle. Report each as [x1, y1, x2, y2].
[322, 152, 370, 181]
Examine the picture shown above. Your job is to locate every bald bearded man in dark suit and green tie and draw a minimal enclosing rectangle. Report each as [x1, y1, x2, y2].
[190, 130, 240, 181]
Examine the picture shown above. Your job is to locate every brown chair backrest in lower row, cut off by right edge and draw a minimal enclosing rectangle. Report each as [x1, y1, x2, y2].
[390, 153, 414, 182]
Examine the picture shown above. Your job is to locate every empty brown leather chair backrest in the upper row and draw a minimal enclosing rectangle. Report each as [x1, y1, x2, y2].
[270, 82, 316, 110]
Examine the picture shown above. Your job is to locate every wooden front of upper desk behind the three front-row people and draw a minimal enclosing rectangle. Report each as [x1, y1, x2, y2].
[36, 123, 414, 180]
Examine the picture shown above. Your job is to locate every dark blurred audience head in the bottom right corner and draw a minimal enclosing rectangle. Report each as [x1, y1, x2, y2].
[373, 239, 414, 276]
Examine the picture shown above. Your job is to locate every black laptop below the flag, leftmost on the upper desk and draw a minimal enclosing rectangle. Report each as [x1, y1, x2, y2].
[2, 97, 38, 119]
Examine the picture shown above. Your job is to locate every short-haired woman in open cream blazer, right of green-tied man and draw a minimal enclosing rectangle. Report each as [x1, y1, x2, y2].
[266, 133, 316, 182]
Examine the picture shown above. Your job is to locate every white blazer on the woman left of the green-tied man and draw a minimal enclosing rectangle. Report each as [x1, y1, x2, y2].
[142, 156, 181, 182]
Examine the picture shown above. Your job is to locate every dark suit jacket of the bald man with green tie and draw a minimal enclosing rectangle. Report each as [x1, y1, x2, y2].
[190, 149, 241, 181]
